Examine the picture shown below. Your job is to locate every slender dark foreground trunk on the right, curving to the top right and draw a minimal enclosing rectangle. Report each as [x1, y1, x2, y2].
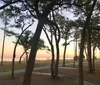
[79, 0, 97, 85]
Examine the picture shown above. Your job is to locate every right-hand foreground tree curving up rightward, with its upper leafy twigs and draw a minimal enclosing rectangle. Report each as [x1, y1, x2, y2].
[71, 0, 97, 85]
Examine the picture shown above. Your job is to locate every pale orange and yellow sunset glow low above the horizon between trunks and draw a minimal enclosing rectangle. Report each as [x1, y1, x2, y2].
[0, 34, 74, 61]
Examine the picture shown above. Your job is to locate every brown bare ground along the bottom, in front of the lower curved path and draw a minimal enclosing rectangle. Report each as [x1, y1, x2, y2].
[0, 74, 77, 85]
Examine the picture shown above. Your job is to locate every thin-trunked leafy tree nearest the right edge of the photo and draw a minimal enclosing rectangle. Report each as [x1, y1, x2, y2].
[91, 14, 100, 71]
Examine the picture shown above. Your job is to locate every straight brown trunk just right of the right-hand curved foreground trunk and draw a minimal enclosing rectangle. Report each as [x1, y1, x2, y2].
[87, 29, 93, 73]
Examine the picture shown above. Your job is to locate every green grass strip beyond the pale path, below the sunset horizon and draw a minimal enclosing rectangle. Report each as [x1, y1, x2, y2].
[0, 60, 71, 72]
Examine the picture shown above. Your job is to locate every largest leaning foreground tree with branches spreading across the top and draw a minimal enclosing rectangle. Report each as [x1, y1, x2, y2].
[0, 0, 94, 85]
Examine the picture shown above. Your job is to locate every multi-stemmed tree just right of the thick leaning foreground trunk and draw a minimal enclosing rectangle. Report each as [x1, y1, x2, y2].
[44, 12, 60, 78]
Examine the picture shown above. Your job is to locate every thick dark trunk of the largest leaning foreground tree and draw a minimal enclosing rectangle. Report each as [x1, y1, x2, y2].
[23, 0, 62, 85]
